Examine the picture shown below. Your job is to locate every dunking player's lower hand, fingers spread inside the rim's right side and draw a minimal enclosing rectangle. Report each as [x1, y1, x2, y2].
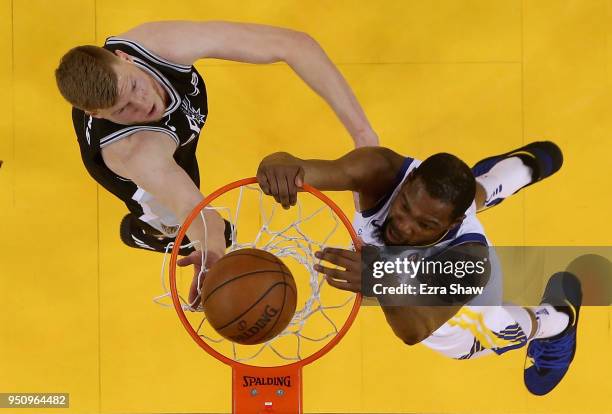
[314, 247, 361, 293]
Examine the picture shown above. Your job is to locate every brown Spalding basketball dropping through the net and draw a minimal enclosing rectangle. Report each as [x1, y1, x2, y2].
[201, 249, 297, 345]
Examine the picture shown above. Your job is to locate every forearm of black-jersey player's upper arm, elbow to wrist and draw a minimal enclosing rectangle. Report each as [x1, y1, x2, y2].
[285, 34, 378, 147]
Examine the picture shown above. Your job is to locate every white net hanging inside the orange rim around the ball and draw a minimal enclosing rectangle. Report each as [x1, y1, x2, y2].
[160, 186, 355, 365]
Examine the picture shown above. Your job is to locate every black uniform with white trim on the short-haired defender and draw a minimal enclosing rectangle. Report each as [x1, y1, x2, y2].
[72, 37, 208, 237]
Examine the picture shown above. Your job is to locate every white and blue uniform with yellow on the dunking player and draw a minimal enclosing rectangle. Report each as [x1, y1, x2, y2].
[353, 158, 527, 359]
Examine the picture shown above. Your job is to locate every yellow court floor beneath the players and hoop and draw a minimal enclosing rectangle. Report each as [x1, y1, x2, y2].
[0, 0, 612, 414]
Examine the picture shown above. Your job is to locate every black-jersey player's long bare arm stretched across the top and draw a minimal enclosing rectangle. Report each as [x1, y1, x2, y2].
[121, 21, 378, 147]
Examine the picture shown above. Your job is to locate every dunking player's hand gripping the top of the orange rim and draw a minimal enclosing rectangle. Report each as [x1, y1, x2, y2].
[257, 157, 304, 209]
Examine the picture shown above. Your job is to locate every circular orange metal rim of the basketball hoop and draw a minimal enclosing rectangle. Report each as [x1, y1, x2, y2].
[170, 177, 361, 368]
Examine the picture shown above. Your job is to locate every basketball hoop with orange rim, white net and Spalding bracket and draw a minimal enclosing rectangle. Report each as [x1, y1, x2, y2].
[167, 177, 361, 414]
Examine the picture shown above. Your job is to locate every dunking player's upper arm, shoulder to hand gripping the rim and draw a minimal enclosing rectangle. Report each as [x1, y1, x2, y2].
[257, 147, 404, 208]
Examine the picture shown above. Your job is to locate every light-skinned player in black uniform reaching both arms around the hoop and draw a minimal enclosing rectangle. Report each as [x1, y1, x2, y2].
[55, 21, 378, 265]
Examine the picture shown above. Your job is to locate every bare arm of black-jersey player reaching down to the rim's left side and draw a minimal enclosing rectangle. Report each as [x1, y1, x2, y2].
[102, 131, 225, 265]
